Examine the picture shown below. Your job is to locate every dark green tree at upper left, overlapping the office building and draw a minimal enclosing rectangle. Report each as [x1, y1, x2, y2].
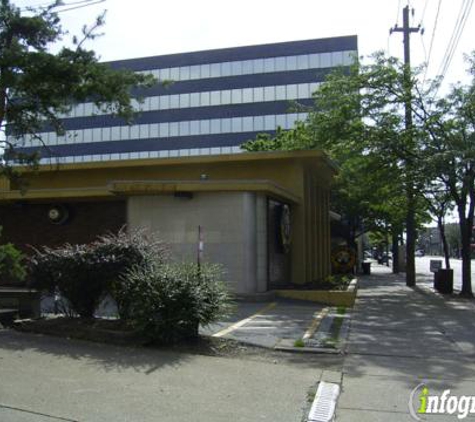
[0, 0, 154, 178]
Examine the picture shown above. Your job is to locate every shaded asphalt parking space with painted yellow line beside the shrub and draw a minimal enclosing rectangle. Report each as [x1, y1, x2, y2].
[201, 300, 324, 347]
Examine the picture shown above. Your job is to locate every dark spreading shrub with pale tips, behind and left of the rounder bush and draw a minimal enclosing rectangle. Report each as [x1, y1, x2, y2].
[30, 230, 165, 318]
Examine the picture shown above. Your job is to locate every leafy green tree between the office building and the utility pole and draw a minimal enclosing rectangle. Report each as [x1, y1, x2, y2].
[244, 54, 426, 278]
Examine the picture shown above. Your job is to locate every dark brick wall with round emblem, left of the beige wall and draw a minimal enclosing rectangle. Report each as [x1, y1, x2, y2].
[0, 201, 127, 252]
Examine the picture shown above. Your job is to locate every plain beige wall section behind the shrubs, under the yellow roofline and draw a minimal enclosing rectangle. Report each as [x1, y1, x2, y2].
[127, 192, 267, 293]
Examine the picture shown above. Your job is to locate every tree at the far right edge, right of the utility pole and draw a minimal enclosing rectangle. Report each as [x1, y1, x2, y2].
[415, 53, 475, 297]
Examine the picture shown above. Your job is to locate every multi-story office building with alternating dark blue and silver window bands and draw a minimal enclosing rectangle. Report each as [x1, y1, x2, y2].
[14, 36, 357, 163]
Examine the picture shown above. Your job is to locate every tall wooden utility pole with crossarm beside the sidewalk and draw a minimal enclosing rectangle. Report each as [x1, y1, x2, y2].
[390, 6, 421, 286]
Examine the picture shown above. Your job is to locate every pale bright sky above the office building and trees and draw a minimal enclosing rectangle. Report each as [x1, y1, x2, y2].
[16, 0, 475, 91]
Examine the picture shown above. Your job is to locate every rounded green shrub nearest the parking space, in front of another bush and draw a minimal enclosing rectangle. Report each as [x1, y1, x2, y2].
[119, 264, 230, 344]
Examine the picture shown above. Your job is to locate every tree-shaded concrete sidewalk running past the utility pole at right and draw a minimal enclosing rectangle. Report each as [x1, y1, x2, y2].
[336, 266, 475, 422]
